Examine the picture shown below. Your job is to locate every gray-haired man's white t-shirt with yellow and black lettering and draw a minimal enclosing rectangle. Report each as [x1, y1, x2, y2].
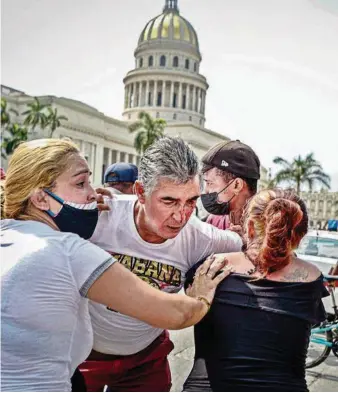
[89, 195, 242, 355]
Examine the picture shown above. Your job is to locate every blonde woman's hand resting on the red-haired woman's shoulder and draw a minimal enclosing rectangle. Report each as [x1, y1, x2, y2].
[186, 255, 232, 304]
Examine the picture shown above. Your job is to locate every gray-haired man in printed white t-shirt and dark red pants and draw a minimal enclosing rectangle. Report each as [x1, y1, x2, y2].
[80, 137, 242, 391]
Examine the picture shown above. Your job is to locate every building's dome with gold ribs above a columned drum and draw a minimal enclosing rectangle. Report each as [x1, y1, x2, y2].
[123, 0, 208, 127]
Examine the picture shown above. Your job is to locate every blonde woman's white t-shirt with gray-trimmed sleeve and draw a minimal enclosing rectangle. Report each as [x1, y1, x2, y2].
[1, 220, 114, 392]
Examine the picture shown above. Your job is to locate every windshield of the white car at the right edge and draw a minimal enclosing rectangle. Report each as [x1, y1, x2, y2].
[296, 236, 338, 259]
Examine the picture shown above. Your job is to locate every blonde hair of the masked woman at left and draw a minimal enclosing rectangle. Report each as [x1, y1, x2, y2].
[1, 139, 79, 220]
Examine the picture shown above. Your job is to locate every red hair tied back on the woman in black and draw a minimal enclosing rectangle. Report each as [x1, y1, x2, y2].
[243, 189, 308, 275]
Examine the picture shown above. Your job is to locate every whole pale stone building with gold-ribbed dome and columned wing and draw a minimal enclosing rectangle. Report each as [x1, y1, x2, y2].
[1, 0, 265, 186]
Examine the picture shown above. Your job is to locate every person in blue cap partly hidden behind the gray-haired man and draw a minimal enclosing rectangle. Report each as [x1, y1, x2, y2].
[104, 162, 138, 194]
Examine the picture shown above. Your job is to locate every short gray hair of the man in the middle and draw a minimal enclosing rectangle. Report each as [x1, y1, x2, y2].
[139, 136, 202, 195]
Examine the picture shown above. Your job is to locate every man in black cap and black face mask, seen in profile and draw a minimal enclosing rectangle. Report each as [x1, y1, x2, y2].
[201, 140, 260, 229]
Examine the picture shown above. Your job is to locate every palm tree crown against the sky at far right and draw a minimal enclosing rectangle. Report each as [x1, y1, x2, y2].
[273, 153, 331, 193]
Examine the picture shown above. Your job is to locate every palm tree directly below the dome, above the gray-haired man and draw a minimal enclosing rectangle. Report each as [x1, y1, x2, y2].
[128, 111, 167, 154]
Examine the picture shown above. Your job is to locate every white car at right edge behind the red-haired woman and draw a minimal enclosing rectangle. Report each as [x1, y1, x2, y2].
[296, 230, 338, 274]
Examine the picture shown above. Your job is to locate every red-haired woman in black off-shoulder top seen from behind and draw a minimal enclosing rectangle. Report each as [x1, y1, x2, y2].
[184, 190, 326, 392]
